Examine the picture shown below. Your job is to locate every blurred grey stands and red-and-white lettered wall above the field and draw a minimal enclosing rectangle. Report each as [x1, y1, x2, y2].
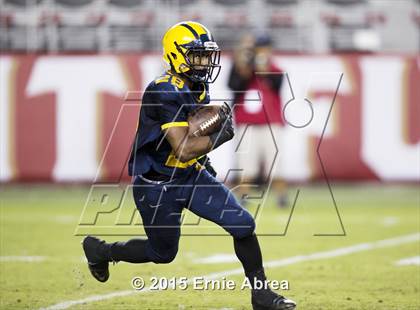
[0, 0, 420, 182]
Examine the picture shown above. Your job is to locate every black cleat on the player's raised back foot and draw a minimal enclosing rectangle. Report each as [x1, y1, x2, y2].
[82, 236, 109, 282]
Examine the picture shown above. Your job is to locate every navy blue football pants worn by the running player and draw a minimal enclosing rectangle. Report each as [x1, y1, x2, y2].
[131, 170, 261, 263]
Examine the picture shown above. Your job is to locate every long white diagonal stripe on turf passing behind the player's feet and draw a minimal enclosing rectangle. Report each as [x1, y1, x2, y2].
[41, 232, 420, 310]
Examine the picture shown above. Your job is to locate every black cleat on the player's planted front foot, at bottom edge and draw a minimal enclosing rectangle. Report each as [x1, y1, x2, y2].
[252, 289, 296, 310]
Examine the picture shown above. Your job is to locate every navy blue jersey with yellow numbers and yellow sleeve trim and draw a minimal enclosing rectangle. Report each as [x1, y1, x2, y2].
[128, 72, 210, 177]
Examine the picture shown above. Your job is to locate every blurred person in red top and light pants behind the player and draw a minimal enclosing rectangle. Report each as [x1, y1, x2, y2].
[229, 34, 287, 207]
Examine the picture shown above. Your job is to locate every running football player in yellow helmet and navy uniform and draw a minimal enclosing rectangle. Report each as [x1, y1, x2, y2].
[82, 21, 296, 309]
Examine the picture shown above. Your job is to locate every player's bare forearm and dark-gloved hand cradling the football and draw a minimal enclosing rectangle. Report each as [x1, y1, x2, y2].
[165, 119, 234, 162]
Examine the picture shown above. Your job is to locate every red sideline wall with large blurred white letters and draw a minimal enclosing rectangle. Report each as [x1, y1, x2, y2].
[0, 54, 420, 182]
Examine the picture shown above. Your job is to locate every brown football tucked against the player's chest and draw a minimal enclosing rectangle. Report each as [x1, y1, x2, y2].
[188, 105, 222, 137]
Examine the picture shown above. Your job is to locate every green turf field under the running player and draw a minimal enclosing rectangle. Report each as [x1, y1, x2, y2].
[0, 185, 420, 310]
